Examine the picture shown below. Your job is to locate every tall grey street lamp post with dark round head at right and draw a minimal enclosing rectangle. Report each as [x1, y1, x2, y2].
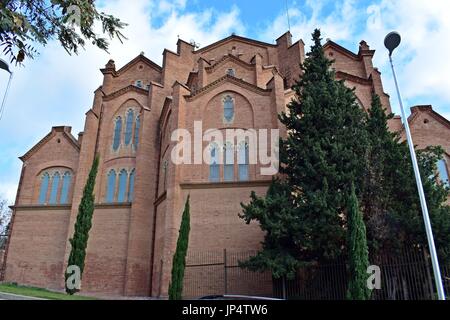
[384, 32, 445, 300]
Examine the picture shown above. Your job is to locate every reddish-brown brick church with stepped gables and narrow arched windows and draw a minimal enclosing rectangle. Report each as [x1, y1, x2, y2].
[2, 32, 450, 297]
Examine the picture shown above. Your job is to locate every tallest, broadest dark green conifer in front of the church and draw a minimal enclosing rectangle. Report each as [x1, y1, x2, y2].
[241, 30, 367, 277]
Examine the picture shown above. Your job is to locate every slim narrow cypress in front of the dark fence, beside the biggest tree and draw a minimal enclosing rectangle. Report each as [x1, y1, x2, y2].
[347, 185, 371, 300]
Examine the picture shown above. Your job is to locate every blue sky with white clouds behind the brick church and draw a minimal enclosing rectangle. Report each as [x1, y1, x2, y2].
[0, 0, 450, 202]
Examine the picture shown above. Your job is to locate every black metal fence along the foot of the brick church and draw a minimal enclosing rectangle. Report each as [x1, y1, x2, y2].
[184, 250, 450, 300]
